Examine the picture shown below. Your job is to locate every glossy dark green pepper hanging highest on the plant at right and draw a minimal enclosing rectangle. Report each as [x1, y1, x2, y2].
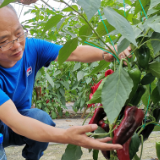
[134, 45, 150, 69]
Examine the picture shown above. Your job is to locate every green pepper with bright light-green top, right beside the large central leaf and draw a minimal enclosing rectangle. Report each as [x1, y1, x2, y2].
[126, 66, 141, 105]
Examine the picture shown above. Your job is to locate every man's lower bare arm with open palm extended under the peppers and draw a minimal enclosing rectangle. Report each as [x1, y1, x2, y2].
[0, 100, 122, 150]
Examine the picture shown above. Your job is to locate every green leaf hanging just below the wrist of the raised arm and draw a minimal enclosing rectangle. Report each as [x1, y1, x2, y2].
[89, 60, 110, 75]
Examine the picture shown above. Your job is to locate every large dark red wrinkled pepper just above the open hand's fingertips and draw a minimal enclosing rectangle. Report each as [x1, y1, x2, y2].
[113, 106, 144, 145]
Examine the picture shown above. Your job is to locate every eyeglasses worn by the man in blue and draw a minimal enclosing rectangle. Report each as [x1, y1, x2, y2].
[0, 25, 28, 51]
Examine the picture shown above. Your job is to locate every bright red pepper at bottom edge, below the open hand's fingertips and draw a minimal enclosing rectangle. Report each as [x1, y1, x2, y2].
[117, 138, 131, 160]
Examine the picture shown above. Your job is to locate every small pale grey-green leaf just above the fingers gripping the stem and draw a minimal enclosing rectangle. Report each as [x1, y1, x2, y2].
[118, 37, 130, 54]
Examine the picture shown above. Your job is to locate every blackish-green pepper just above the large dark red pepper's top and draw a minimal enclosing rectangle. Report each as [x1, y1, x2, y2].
[130, 85, 146, 106]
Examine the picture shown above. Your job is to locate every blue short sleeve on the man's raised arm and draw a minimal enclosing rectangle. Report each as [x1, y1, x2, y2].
[32, 38, 62, 69]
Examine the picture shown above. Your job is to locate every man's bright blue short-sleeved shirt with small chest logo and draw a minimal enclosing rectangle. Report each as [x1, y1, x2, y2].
[0, 38, 62, 111]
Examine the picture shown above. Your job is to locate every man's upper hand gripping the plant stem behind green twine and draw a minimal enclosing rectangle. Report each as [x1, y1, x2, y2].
[104, 45, 132, 64]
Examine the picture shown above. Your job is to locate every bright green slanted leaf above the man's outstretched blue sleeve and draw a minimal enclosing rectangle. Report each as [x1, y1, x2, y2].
[42, 14, 63, 34]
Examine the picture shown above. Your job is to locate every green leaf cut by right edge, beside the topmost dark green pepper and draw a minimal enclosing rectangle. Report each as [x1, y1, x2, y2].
[149, 61, 160, 78]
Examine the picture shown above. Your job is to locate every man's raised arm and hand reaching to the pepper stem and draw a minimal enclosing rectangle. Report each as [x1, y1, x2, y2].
[56, 45, 131, 63]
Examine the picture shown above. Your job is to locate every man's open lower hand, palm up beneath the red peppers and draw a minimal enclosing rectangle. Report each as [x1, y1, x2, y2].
[65, 124, 122, 151]
